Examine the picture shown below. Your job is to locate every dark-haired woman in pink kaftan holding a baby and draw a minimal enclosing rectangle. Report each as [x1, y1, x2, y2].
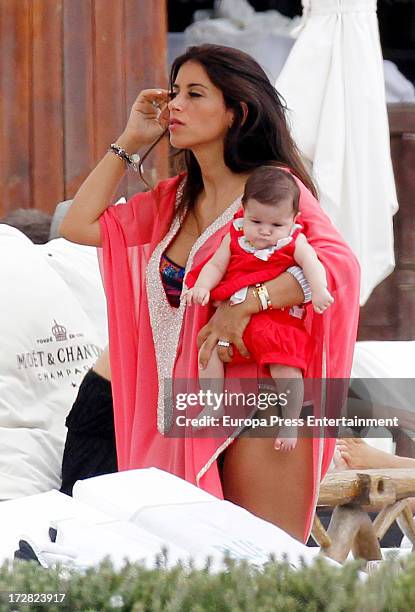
[61, 45, 359, 541]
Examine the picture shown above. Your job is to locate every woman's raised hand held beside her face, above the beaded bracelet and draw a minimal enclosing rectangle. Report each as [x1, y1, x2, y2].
[117, 89, 169, 154]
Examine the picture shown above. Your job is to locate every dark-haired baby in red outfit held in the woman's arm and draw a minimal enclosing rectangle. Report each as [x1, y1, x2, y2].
[182, 166, 333, 450]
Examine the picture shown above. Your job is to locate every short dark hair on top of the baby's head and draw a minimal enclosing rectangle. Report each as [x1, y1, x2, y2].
[242, 166, 300, 215]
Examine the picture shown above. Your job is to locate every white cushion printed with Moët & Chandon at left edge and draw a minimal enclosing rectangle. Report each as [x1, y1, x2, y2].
[0, 225, 103, 500]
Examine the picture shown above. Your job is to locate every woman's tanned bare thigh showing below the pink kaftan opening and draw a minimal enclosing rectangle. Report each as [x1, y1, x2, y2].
[222, 437, 313, 541]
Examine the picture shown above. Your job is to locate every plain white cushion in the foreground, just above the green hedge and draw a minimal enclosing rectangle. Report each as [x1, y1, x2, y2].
[75, 468, 324, 569]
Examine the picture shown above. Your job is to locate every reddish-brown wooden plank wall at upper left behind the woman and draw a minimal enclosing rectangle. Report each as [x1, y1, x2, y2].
[0, 0, 167, 216]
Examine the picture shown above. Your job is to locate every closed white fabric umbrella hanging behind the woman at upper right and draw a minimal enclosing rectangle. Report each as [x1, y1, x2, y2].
[276, 0, 398, 304]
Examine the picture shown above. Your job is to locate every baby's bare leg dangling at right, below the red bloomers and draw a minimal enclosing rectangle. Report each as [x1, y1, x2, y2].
[269, 363, 304, 450]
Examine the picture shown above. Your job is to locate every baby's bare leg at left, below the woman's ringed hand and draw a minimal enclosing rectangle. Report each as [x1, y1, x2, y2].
[198, 345, 225, 426]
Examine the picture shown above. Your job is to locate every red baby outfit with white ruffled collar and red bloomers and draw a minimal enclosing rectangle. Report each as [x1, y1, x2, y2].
[185, 211, 312, 374]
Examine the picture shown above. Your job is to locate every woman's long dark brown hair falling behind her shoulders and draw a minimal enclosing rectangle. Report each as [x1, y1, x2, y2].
[141, 44, 317, 209]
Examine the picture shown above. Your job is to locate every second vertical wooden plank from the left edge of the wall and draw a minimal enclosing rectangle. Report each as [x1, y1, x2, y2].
[31, 0, 64, 213]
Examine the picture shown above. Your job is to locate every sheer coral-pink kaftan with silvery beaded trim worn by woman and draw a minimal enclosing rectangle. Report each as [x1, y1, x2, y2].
[100, 175, 359, 539]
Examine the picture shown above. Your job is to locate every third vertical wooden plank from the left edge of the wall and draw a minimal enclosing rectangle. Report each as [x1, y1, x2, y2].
[63, 0, 96, 199]
